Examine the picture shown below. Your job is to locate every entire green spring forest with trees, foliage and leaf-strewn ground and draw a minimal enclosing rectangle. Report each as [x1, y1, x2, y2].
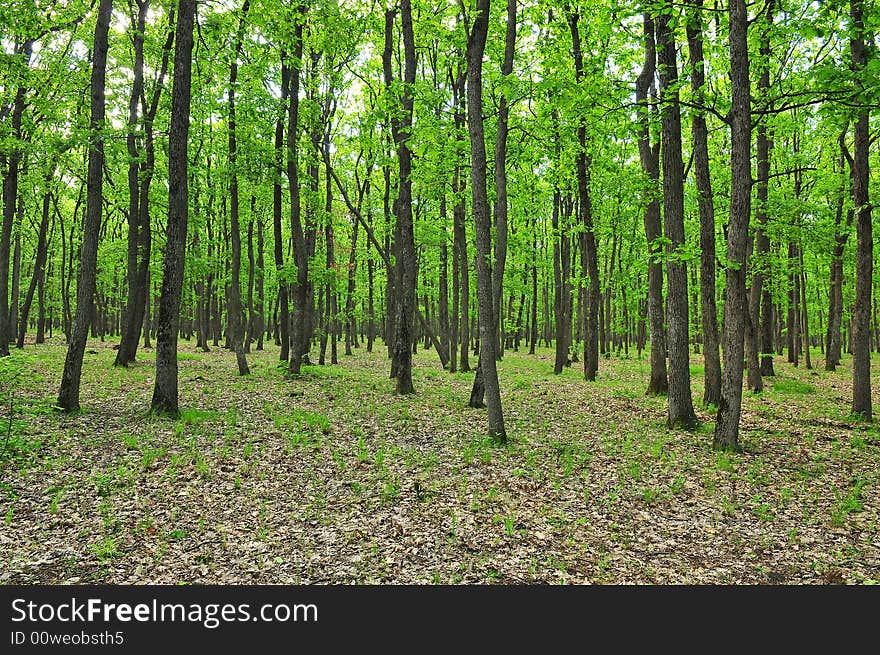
[0, 0, 880, 585]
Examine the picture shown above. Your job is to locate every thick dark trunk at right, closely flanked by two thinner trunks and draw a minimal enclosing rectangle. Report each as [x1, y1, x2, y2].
[657, 13, 697, 427]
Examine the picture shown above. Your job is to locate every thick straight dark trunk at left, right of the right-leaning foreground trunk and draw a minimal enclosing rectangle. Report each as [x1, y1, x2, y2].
[151, 0, 196, 416]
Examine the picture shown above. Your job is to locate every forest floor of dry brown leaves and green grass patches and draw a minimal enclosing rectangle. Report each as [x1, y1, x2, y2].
[0, 339, 880, 584]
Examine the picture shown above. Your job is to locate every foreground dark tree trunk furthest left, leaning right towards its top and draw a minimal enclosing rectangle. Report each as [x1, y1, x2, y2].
[55, 0, 113, 412]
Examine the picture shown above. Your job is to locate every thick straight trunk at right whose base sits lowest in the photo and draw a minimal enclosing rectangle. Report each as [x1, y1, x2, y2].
[713, 0, 752, 450]
